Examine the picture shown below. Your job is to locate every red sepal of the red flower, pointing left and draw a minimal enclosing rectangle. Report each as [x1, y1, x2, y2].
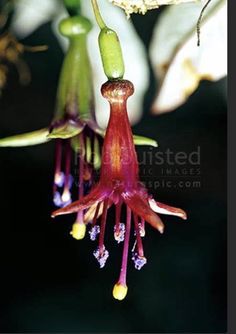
[51, 185, 110, 218]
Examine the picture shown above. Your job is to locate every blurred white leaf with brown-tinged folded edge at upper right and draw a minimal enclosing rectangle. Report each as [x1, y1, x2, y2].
[150, 0, 227, 113]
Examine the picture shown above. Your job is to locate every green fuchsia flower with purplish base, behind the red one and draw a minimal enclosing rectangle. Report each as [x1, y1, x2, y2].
[0, 15, 157, 239]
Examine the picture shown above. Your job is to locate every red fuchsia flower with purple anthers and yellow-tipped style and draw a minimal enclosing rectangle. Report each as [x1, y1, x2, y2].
[52, 80, 187, 300]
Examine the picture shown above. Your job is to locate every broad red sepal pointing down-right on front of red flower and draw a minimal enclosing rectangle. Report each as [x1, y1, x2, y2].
[122, 193, 164, 233]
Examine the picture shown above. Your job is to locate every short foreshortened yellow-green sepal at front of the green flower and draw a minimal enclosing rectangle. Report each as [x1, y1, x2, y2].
[47, 121, 84, 139]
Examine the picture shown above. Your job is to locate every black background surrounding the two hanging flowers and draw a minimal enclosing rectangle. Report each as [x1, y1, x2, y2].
[0, 6, 227, 333]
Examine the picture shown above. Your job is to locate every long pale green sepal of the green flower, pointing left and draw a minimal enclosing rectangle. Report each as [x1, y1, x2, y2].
[0, 128, 49, 147]
